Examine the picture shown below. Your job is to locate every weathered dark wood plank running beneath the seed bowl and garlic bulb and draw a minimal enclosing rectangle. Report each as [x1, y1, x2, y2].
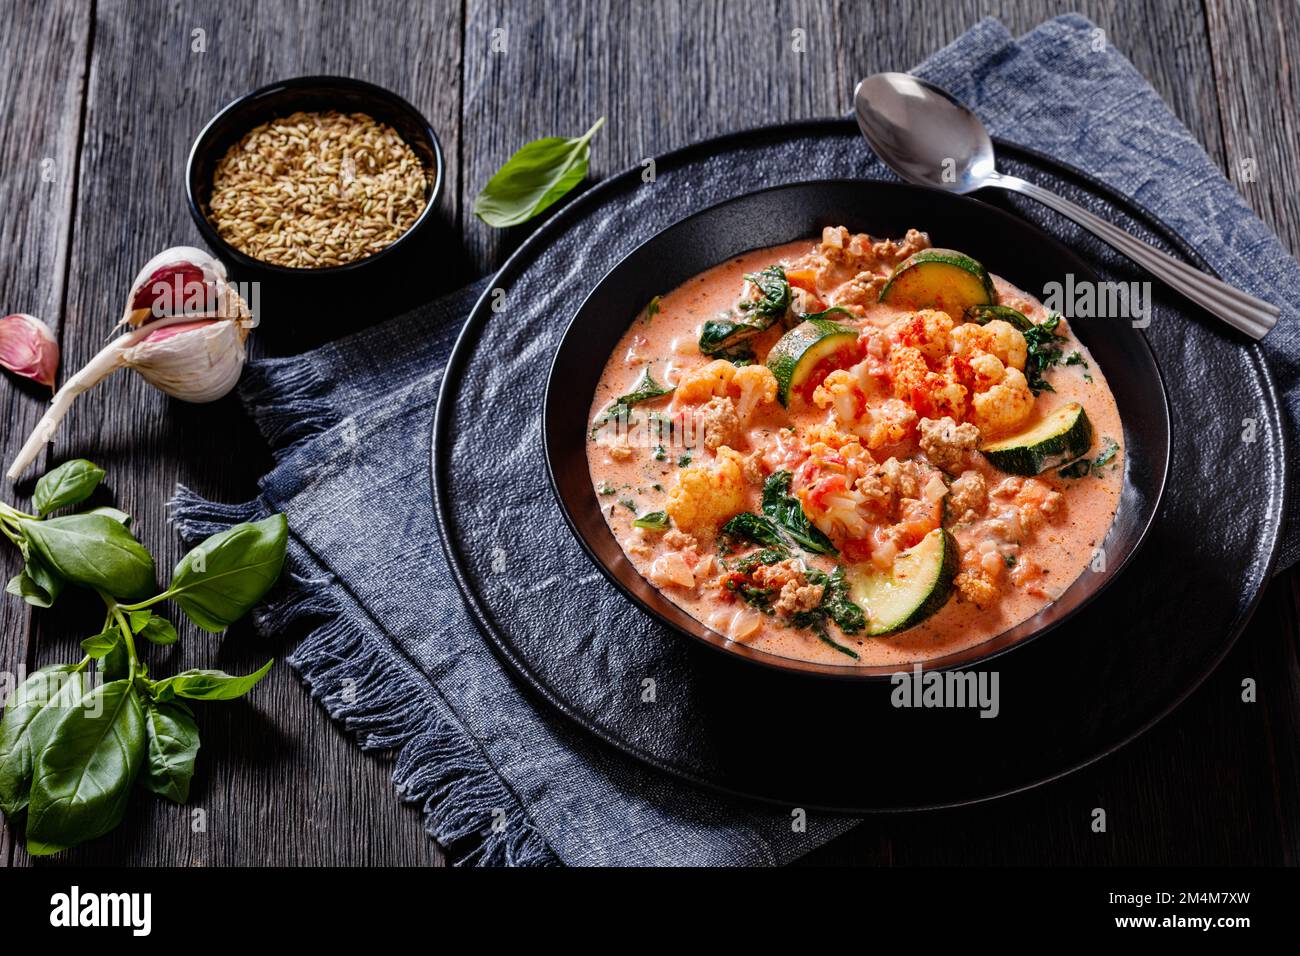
[8, 0, 460, 865]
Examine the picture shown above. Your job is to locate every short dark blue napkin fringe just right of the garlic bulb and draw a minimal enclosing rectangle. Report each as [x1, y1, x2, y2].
[239, 355, 338, 462]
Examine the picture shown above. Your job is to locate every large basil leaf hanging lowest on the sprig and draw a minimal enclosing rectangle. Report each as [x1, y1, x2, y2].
[27, 680, 146, 856]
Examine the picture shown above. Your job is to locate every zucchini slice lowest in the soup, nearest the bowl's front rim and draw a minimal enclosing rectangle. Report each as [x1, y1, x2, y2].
[848, 528, 961, 637]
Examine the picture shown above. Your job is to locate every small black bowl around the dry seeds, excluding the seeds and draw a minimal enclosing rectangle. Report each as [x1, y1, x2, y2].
[185, 77, 443, 278]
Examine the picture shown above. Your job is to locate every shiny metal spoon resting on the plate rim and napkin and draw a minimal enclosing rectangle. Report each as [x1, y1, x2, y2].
[853, 73, 1281, 339]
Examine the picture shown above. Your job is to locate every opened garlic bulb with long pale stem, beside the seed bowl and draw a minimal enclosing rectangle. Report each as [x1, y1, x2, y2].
[7, 246, 254, 479]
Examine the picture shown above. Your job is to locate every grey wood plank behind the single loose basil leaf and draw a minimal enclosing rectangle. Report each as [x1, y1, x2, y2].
[462, 0, 840, 269]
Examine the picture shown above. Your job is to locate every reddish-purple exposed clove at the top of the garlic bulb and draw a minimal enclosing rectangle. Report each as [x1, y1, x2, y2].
[121, 246, 243, 328]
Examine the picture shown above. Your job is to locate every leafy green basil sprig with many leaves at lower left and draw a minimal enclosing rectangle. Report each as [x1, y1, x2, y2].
[0, 459, 289, 856]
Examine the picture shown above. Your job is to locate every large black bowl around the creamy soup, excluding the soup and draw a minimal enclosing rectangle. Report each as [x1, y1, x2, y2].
[542, 179, 1170, 680]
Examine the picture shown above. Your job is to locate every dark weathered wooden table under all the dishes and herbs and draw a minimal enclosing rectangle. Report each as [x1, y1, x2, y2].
[0, 0, 1300, 866]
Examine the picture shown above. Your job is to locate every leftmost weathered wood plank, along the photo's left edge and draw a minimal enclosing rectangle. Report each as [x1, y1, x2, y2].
[0, 0, 91, 866]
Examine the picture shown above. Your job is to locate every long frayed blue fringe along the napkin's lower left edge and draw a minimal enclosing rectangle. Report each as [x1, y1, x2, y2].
[168, 485, 558, 866]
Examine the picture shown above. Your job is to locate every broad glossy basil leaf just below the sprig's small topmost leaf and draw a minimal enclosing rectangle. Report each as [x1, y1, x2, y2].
[21, 515, 153, 598]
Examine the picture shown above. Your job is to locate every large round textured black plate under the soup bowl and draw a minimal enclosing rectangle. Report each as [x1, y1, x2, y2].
[432, 115, 1288, 813]
